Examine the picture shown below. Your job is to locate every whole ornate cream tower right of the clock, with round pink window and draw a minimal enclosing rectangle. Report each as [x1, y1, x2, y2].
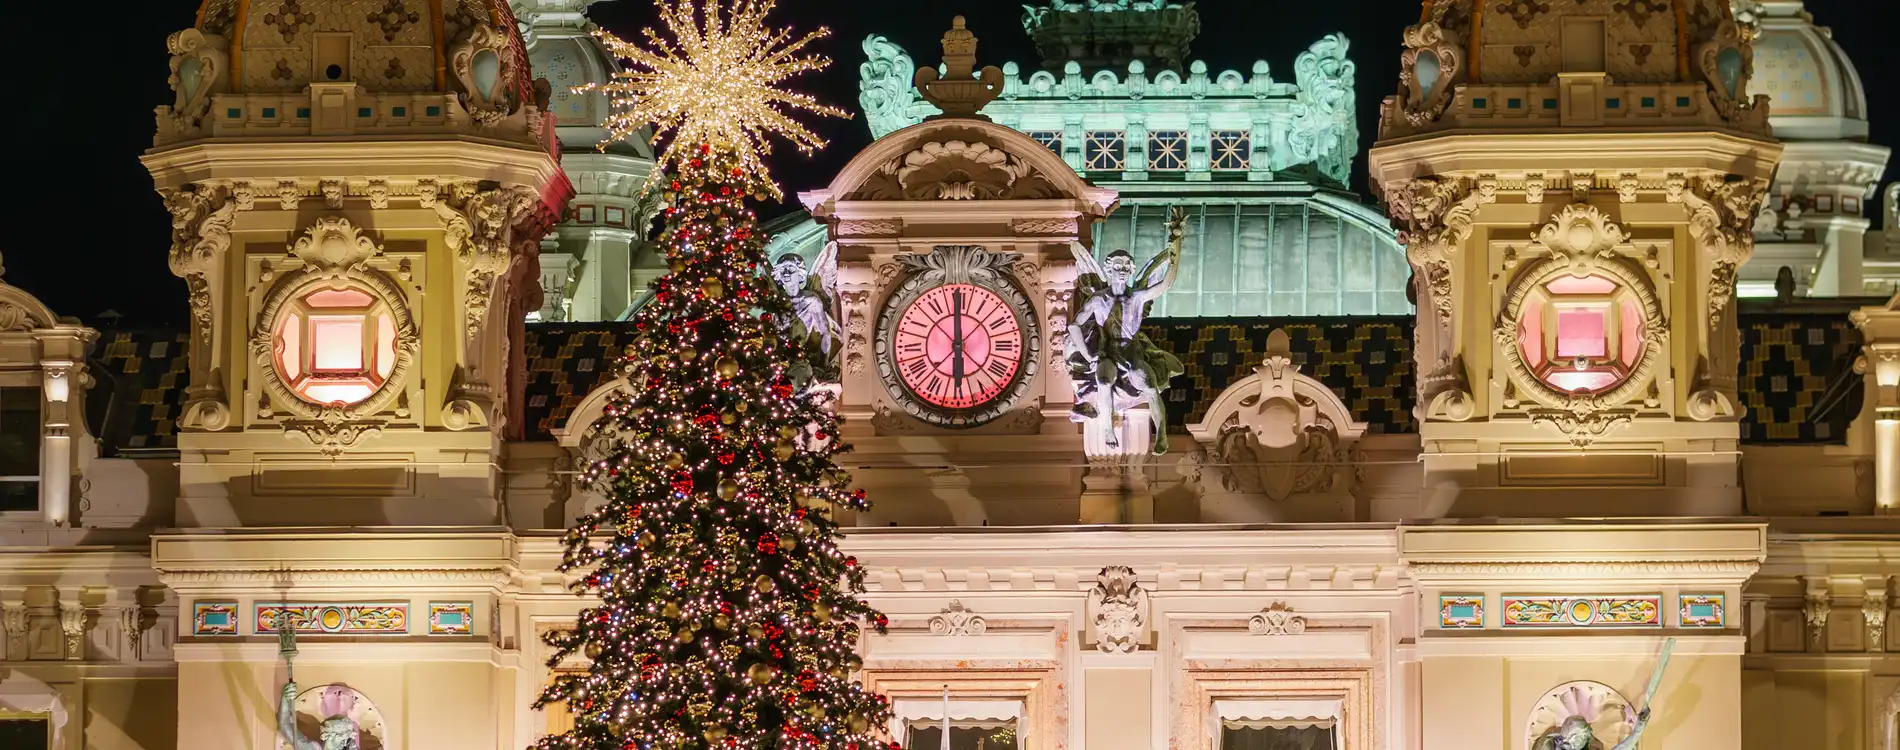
[1372, 0, 1780, 516]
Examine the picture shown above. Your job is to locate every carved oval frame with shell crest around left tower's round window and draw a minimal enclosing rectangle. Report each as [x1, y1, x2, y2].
[249, 216, 422, 456]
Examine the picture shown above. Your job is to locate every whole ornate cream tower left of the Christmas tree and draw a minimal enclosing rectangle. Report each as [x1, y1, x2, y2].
[144, 0, 572, 528]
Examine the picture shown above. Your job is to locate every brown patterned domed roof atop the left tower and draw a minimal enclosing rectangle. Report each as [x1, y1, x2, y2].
[196, 0, 532, 101]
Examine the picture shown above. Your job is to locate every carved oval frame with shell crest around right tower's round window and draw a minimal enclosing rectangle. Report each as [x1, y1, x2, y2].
[1492, 203, 1668, 446]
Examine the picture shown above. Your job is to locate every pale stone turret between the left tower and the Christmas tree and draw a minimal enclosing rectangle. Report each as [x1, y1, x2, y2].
[513, 0, 665, 321]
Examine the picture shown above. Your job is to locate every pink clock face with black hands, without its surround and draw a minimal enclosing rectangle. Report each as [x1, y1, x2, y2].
[891, 285, 1022, 408]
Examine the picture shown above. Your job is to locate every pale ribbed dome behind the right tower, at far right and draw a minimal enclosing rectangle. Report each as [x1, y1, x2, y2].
[1735, 0, 1868, 141]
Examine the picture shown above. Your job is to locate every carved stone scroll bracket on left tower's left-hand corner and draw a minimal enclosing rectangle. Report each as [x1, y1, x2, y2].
[163, 184, 238, 431]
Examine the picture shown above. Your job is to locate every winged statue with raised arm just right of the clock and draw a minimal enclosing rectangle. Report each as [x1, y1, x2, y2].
[1064, 207, 1188, 456]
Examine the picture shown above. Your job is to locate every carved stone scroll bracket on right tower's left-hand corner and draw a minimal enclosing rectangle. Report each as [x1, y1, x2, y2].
[1385, 175, 1497, 422]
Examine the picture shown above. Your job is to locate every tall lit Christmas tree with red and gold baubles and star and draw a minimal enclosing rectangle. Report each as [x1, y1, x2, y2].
[536, 0, 889, 750]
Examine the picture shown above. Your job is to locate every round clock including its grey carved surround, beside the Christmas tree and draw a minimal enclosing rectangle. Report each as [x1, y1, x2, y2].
[878, 247, 1041, 427]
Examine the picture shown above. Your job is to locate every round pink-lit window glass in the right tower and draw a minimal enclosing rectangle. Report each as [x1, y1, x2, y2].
[1518, 275, 1644, 393]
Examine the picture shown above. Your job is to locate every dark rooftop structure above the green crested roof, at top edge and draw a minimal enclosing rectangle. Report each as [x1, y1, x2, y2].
[1022, 0, 1201, 70]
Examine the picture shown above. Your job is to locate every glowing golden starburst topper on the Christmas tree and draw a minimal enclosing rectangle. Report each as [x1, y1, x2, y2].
[578, 0, 849, 196]
